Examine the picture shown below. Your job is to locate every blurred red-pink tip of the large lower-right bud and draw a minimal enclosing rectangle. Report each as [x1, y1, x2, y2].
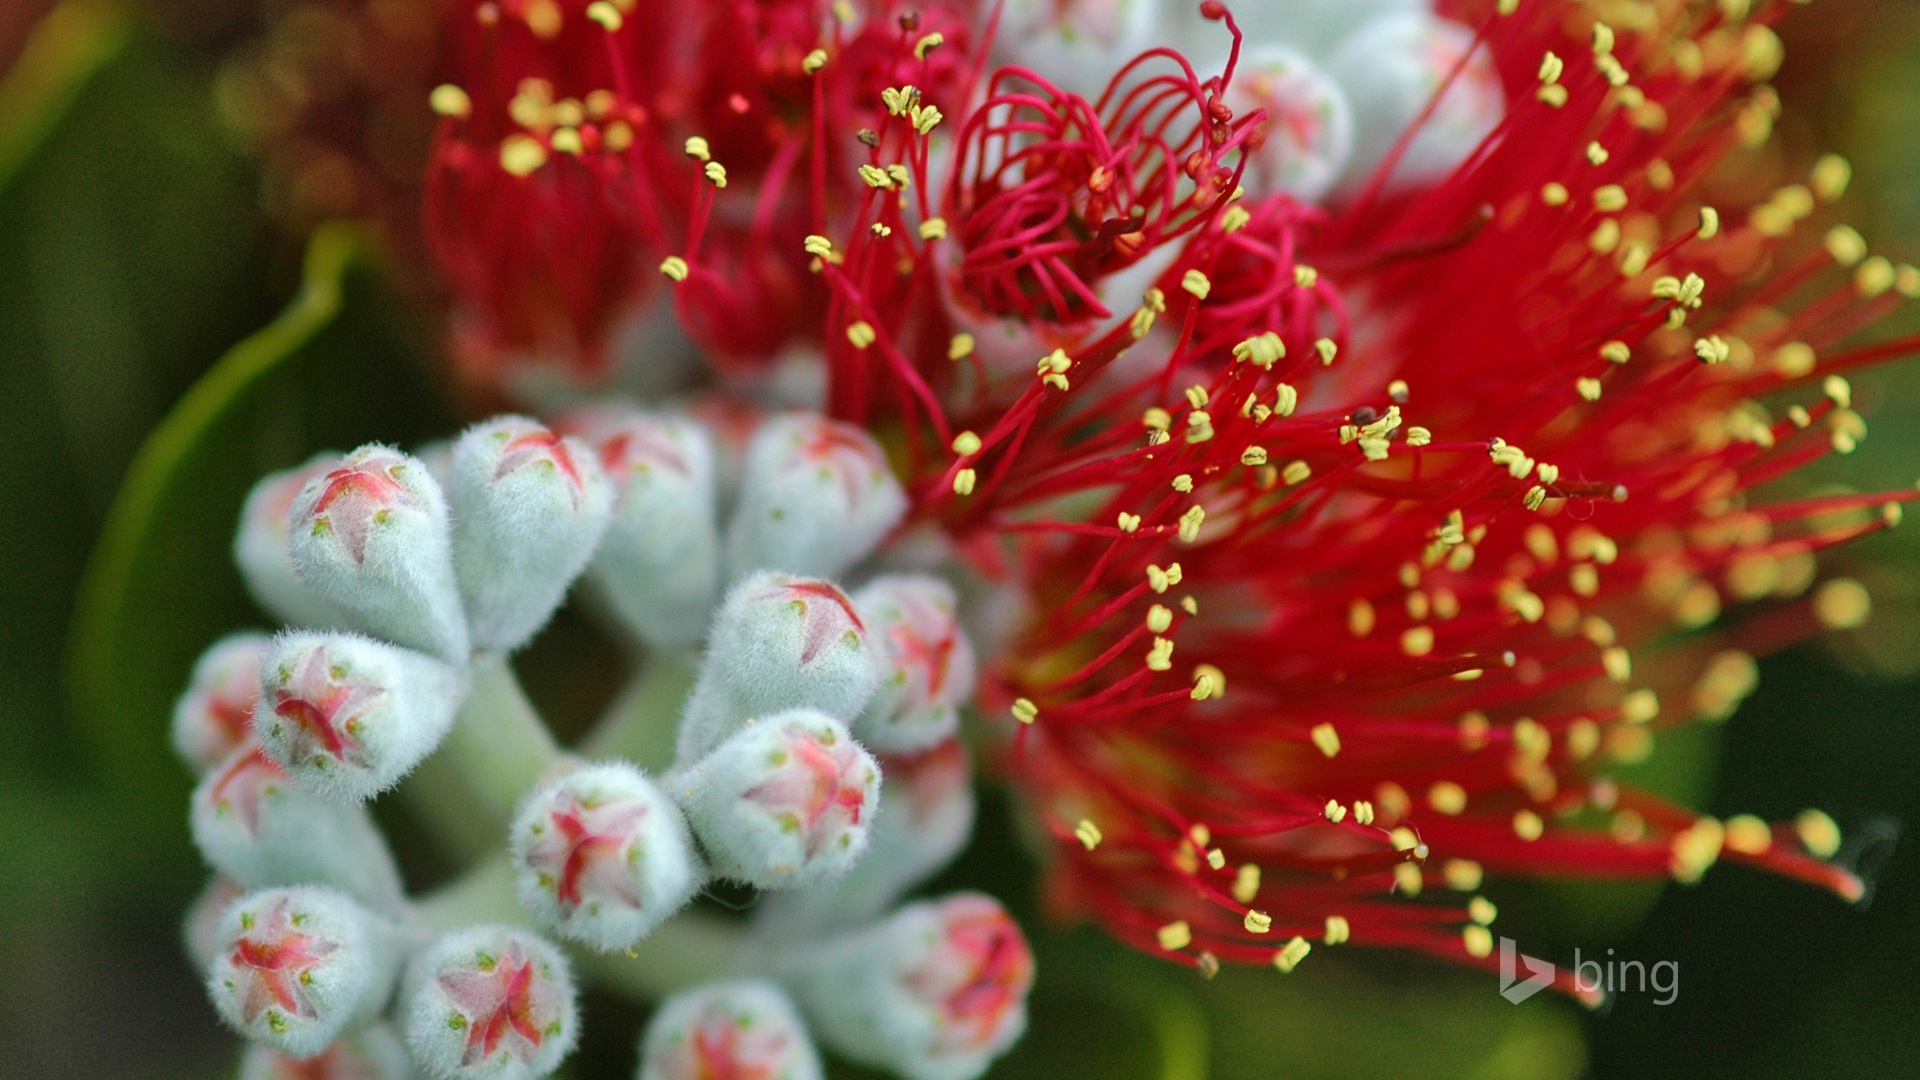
[904, 897, 1033, 1051]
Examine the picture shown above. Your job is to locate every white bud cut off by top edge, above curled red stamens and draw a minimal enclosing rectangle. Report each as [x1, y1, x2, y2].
[993, 0, 1160, 100]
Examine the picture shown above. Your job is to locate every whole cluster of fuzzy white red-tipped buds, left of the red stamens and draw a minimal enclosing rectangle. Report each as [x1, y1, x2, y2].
[173, 409, 1033, 1080]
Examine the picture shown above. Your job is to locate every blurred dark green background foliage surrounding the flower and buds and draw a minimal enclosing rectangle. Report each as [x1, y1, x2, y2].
[0, 0, 1920, 1080]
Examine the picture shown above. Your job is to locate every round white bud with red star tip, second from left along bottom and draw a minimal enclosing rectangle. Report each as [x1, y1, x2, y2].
[397, 914, 580, 1080]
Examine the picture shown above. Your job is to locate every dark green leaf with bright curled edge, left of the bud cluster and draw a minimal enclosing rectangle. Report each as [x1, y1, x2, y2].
[67, 225, 442, 826]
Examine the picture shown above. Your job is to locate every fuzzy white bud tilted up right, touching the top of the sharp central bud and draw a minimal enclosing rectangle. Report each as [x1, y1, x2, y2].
[678, 573, 881, 763]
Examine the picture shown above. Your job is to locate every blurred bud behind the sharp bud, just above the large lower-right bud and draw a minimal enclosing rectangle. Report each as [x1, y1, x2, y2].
[756, 740, 973, 934]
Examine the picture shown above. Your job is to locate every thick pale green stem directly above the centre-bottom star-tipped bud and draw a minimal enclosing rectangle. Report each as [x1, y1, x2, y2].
[445, 653, 561, 822]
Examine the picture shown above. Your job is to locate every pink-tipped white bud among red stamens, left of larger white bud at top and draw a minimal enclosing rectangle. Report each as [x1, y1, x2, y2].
[1227, 44, 1354, 202]
